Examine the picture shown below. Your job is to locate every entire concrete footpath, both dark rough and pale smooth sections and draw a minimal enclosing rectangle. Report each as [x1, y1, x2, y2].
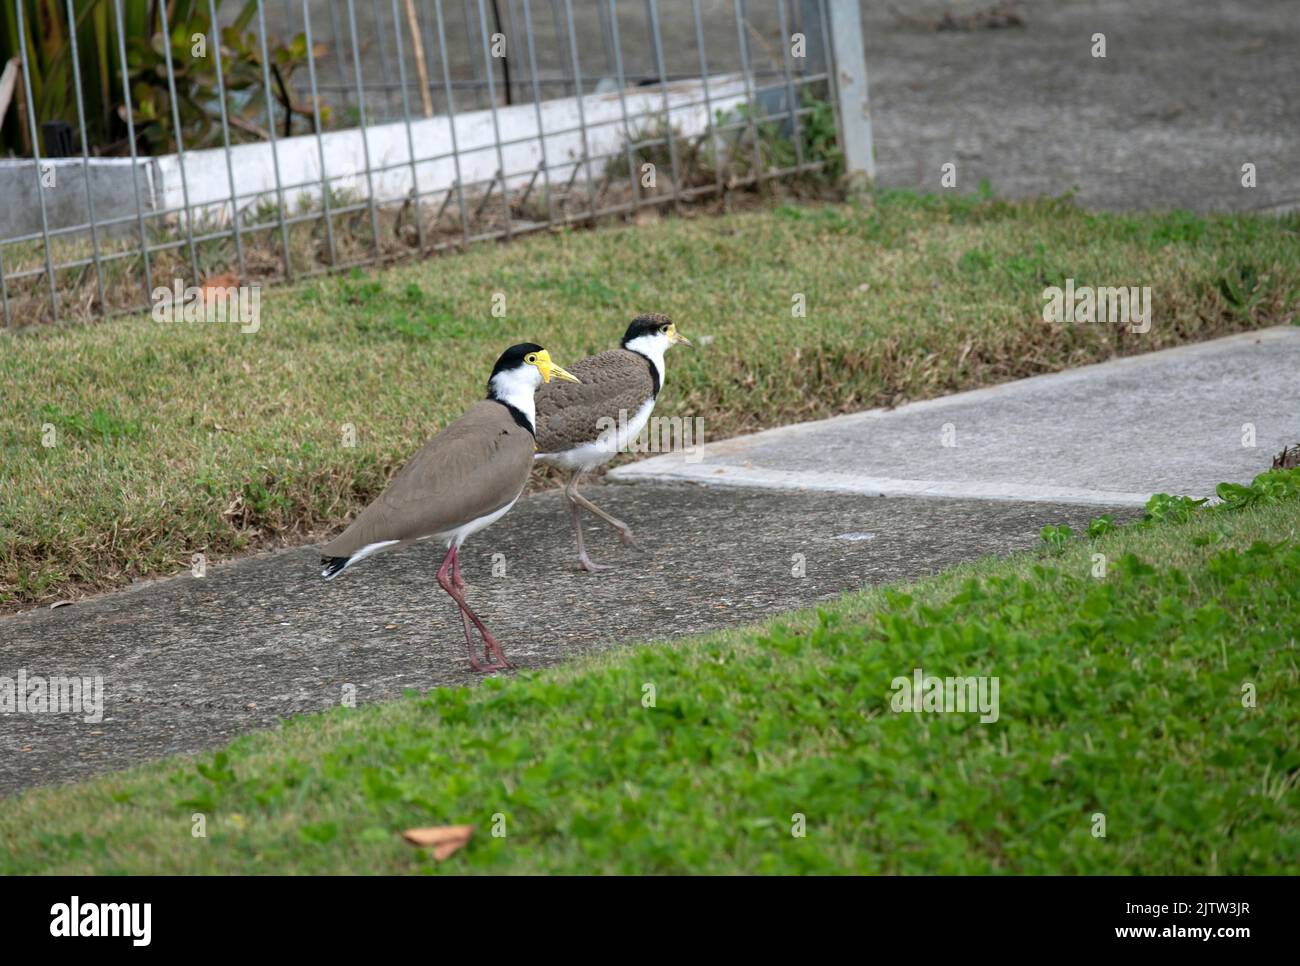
[0, 329, 1300, 794]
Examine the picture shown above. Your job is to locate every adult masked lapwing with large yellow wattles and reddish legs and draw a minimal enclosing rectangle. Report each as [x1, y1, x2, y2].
[321, 342, 577, 671]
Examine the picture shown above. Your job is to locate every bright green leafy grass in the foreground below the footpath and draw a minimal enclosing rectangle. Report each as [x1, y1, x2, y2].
[0, 471, 1300, 874]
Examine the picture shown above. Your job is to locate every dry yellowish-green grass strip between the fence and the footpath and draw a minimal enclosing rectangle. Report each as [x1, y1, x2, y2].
[0, 192, 1300, 610]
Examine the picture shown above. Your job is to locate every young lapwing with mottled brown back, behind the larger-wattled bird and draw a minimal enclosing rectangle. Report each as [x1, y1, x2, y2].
[537, 315, 690, 571]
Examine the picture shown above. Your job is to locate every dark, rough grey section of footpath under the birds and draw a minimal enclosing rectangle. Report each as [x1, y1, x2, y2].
[0, 485, 1118, 794]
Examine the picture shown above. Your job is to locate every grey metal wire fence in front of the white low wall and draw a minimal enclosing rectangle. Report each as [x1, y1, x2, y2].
[0, 0, 871, 326]
